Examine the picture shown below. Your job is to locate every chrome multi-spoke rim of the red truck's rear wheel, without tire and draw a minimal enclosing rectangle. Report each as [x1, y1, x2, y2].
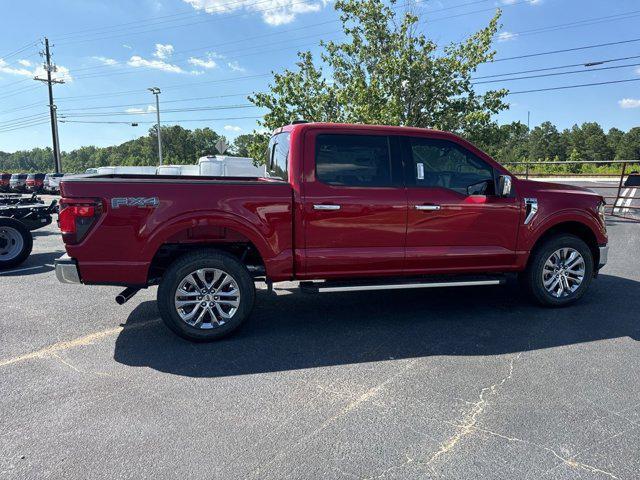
[174, 268, 240, 330]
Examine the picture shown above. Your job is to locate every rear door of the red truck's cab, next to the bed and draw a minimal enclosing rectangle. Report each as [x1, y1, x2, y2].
[299, 129, 407, 278]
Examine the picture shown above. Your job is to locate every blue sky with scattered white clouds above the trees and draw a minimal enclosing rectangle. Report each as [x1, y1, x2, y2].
[0, 0, 640, 151]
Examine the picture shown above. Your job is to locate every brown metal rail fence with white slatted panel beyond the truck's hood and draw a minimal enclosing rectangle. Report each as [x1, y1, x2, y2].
[504, 160, 640, 221]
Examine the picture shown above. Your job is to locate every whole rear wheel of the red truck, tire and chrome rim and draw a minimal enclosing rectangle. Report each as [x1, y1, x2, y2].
[158, 250, 255, 342]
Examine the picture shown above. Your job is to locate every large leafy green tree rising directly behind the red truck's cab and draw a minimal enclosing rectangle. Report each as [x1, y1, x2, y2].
[249, 0, 507, 158]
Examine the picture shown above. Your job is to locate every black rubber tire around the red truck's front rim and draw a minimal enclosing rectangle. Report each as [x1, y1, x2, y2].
[521, 234, 594, 307]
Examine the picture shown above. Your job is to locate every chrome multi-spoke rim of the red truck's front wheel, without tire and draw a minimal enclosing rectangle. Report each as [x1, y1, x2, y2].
[542, 247, 585, 298]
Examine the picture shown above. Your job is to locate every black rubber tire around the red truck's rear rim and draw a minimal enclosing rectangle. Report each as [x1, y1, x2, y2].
[157, 249, 255, 342]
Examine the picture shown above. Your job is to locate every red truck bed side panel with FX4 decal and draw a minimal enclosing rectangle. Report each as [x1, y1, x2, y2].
[60, 175, 293, 285]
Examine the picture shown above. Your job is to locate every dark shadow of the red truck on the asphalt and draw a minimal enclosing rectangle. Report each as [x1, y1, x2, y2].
[114, 275, 640, 377]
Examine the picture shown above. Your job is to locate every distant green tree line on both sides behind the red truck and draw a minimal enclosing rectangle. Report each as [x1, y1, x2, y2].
[0, 122, 640, 173]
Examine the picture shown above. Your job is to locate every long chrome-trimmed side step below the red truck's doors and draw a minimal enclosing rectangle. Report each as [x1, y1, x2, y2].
[300, 276, 506, 293]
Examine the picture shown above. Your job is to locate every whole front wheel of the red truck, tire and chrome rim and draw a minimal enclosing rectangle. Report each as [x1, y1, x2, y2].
[522, 235, 594, 307]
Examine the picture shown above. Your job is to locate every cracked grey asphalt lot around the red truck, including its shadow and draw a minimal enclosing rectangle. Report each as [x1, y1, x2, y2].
[0, 193, 640, 479]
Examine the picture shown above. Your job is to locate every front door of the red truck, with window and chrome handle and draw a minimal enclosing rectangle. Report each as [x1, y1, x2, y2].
[403, 137, 519, 273]
